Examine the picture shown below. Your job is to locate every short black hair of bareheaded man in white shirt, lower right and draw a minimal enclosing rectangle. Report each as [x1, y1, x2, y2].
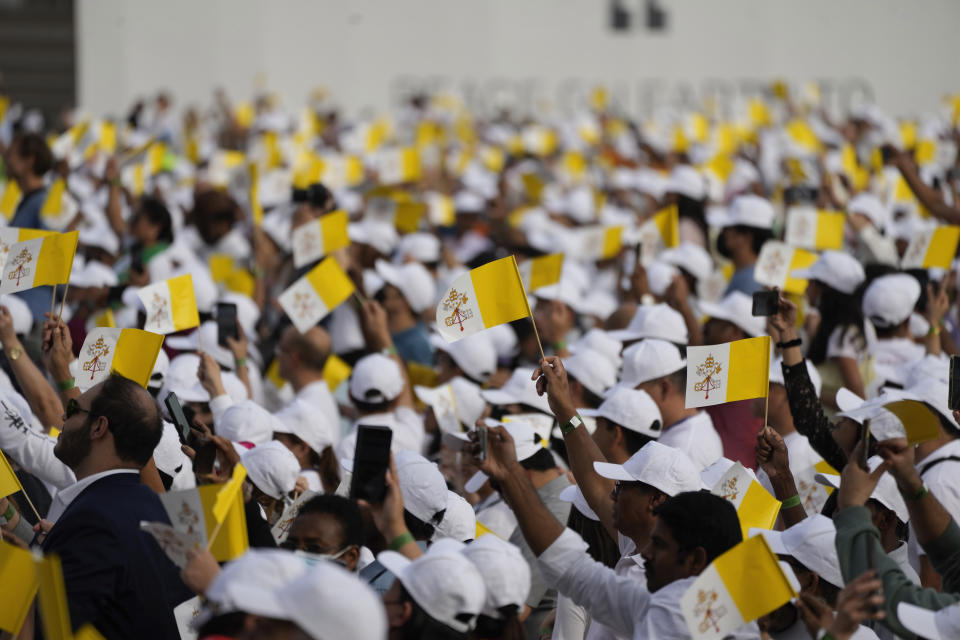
[653, 491, 743, 563]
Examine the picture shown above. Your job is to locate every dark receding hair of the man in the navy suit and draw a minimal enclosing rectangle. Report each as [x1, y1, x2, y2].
[87, 374, 163, 467]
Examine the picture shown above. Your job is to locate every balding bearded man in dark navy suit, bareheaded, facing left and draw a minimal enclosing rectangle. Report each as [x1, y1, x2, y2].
[43, 375, 192, 639]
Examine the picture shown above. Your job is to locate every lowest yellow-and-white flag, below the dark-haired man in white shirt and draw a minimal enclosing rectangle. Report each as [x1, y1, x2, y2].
[680, 536, 797, 640]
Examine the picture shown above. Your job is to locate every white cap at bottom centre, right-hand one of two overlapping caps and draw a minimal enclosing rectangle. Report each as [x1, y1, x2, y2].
[460, 535, 530, 618]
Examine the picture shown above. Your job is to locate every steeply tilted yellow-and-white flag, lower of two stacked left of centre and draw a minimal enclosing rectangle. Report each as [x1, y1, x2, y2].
[278, 257, 354, 333]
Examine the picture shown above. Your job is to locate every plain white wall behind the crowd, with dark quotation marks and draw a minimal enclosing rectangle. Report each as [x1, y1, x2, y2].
[77, 0, 960, 120]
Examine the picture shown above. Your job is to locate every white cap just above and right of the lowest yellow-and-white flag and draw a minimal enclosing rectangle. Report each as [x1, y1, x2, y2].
[750, 513, 844, 588]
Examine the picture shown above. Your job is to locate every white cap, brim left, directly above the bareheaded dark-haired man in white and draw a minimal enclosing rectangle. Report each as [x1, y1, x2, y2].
[593, 442, 703, 496]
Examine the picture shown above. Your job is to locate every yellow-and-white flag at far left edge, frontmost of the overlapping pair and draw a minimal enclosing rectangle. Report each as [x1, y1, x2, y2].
[0, 231, 79, 293]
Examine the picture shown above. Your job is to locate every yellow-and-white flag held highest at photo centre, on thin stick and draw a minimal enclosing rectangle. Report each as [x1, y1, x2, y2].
[437, 256, 530, 342]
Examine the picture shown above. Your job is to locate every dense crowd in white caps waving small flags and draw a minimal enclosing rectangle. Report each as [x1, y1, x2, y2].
[0, 83, 960, 640]
